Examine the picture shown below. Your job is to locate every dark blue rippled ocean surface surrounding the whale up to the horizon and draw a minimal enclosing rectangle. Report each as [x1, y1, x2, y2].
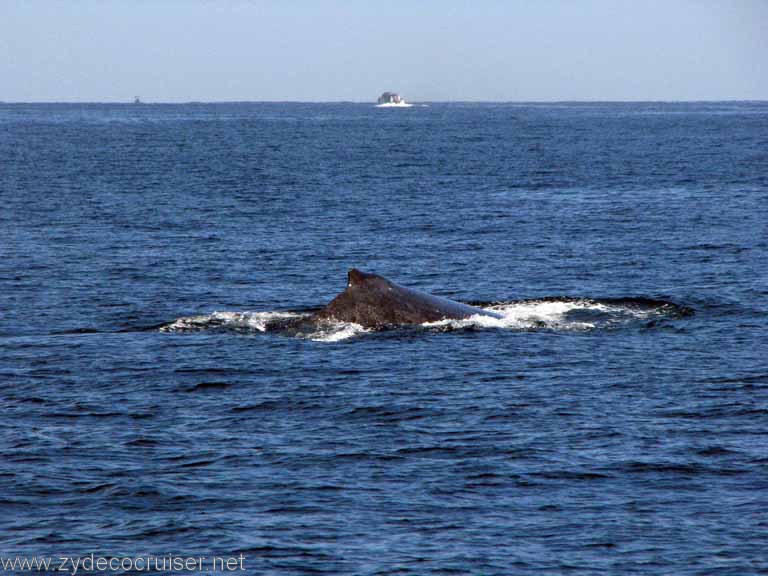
[0, 102, 768, 576]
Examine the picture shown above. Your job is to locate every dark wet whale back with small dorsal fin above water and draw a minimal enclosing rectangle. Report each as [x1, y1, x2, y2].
[315, 268, 501, 329]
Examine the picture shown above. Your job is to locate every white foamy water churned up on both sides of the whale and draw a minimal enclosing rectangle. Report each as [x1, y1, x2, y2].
[159, 297, 693, 342]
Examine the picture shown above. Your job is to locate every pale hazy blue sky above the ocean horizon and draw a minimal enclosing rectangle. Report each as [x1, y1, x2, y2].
[0, 0, 768, 102]
